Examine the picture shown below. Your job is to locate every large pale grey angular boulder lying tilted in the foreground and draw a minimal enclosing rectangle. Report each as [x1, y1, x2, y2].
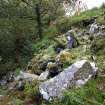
[39, 60, 97, 100]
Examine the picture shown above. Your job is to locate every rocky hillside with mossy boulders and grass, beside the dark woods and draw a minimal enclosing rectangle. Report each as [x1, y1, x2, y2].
[0, 6, 105, 105]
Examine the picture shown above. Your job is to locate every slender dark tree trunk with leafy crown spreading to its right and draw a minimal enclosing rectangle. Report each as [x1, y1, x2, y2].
[21, 0, 64, 39]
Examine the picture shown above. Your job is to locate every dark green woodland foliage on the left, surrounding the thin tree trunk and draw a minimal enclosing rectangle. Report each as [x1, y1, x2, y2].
[0, 0, 63, 74]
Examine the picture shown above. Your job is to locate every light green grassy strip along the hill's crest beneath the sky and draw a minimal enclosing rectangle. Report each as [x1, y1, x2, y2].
[56, 8, 102, 33]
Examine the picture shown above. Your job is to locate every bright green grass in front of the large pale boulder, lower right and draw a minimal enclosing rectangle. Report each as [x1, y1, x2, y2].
[49, 79, 104, 105]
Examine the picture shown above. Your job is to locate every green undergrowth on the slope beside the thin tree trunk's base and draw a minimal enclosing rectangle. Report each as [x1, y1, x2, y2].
[32, 25, 58, 53]
